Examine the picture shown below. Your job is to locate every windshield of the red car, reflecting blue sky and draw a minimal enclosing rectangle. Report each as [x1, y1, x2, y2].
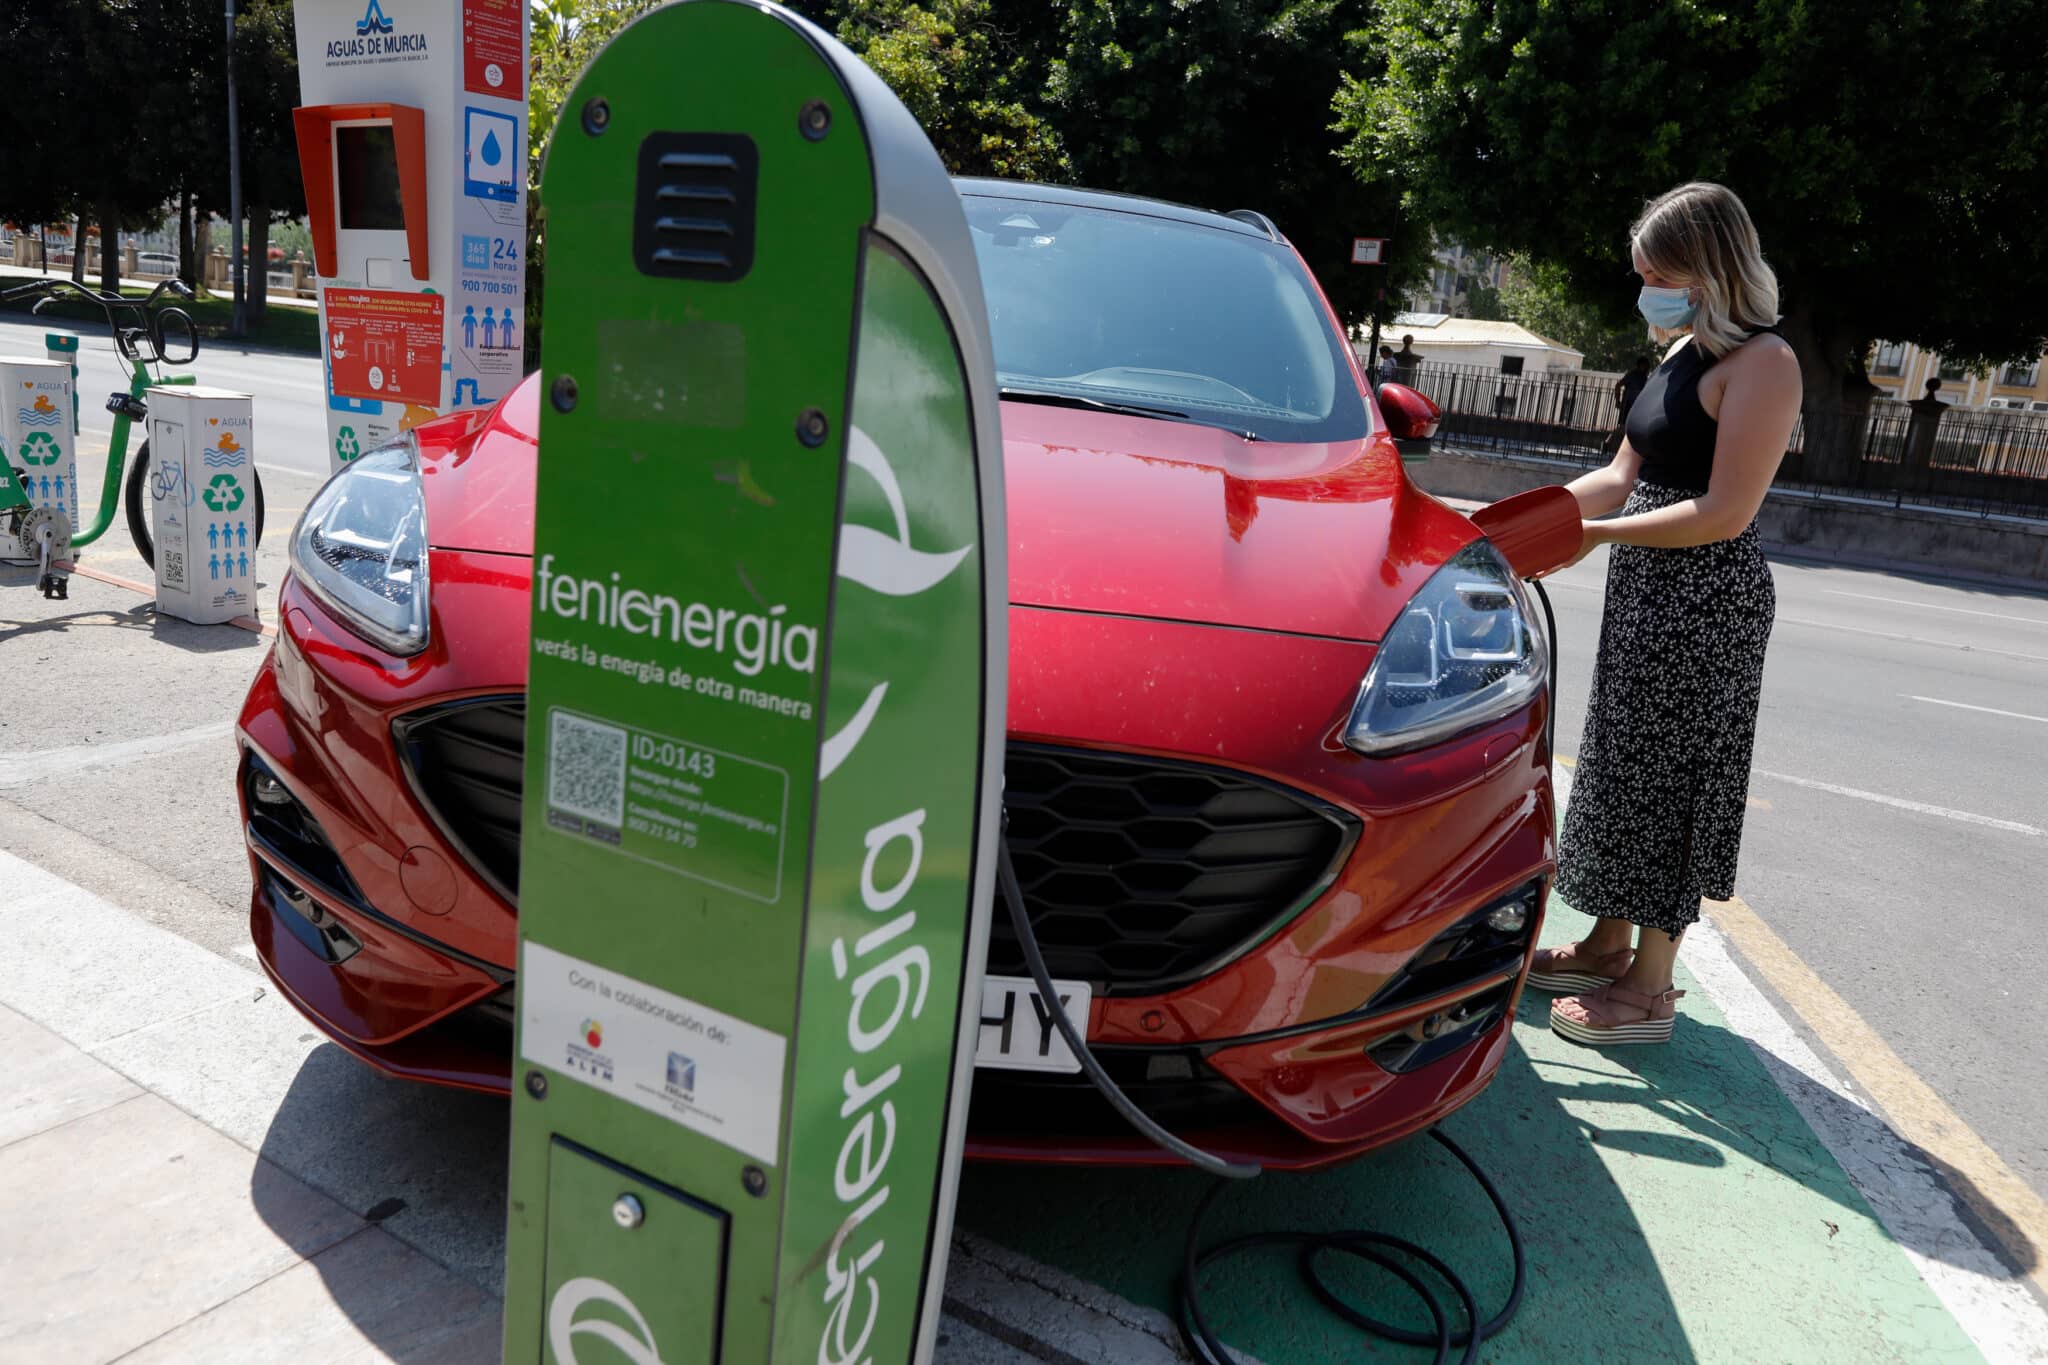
[963, 194, 1368, 442]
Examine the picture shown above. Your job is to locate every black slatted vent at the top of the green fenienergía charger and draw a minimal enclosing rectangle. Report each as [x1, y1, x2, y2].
[633, 133, 760, 284]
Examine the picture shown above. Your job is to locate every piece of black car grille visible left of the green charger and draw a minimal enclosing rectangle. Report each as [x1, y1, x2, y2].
[391, 696, 526, 902]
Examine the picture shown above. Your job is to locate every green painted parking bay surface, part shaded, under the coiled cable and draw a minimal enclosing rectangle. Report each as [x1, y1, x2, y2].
[958, 902, 1982, 1365]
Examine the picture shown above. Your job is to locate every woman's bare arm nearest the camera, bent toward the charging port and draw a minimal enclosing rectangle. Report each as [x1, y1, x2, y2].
[1581, 342, 1800, 548]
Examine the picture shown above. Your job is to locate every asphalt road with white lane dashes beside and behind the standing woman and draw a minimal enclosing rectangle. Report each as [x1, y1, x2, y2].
[1550, 553, 2048, 1193]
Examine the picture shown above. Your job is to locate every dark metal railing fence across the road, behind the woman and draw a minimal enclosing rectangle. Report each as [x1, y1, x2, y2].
[1403, 360, 2048, 520]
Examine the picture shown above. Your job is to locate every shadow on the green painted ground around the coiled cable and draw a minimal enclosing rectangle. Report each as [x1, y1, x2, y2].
[958, 1005, 1720, 1365]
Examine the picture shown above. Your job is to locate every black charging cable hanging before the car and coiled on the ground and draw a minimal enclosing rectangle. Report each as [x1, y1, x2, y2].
[995, 818, 1523, 1365]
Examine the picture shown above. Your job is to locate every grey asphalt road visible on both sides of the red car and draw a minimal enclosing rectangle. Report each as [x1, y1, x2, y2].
[12, 331, 2048, 1227]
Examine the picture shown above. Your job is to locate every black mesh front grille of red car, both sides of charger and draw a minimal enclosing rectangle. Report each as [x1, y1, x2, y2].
[395, 696, 1358, 995]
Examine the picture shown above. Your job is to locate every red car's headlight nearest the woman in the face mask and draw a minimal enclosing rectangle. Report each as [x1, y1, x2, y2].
[1343, 540, 1548, 757]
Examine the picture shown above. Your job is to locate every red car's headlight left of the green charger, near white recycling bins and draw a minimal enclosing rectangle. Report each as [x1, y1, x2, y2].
[291, 432, 426, 657]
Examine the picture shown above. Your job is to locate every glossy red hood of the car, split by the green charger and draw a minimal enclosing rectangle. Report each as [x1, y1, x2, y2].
[418, 377, 1477, 641]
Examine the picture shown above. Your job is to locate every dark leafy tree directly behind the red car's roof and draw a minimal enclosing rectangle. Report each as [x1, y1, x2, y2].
[1047, 0, 1432, 323]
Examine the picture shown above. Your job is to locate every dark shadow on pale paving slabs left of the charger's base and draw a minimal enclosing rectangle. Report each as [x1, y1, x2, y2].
[250, 1044, 510, 1365]
